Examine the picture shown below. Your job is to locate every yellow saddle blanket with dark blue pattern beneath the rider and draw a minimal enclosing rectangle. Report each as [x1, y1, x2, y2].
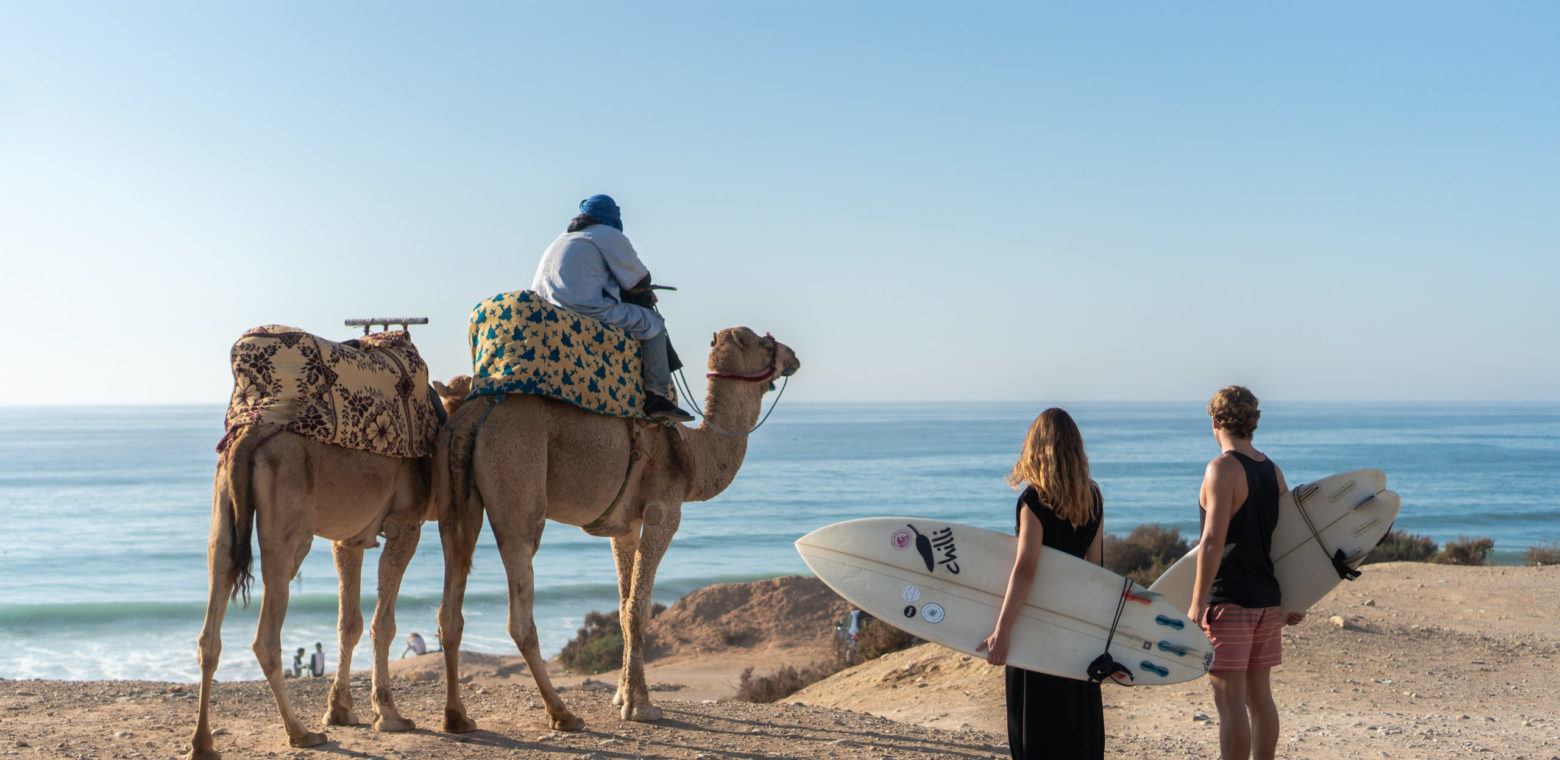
[470, 290, 644, 417]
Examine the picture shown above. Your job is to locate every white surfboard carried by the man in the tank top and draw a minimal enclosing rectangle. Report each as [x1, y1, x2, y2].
[1150, 470, 1401, 613]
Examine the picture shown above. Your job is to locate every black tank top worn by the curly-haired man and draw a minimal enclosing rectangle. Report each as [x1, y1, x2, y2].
[1201, 451, 1282, 607]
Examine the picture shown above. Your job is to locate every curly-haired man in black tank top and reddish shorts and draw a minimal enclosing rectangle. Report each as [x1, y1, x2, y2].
[1187, 385, 1306, 760]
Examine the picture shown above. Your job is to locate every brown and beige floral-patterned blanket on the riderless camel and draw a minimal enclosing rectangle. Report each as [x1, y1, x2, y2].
[218, 325, 441, 459]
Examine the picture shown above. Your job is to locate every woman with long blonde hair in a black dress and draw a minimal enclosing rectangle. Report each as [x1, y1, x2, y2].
[975, 407, 1104, 760]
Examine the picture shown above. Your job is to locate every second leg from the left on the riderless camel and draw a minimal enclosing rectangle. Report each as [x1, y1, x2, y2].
[251, 467, 324, 748]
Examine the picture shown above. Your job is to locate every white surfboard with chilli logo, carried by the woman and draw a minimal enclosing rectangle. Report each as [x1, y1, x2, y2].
[796, 517, 1214, 685]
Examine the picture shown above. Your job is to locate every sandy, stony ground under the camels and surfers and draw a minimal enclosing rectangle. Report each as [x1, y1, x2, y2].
[0, 563, 1560, 760]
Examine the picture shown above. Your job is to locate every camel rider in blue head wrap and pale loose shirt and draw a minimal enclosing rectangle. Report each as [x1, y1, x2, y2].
[530, 195, 693, 421]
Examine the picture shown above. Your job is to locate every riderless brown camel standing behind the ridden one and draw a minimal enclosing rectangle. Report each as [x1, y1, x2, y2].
[189, 379, 465, 760]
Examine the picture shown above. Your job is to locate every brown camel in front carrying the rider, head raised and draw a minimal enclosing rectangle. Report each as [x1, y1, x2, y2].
[434, 328, 802, 732]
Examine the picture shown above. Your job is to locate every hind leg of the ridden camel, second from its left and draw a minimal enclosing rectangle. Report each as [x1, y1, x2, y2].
[491, 509, 585, 730]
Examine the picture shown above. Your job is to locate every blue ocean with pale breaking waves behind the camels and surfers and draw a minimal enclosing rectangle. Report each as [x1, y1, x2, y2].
[0, 401, 1560, 682]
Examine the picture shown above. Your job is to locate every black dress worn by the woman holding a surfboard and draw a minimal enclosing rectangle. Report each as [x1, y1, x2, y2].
[1008, 484, 1104, 760]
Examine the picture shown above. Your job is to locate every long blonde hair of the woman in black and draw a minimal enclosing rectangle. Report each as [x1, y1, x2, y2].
[1008, 407, 1094, 527]
